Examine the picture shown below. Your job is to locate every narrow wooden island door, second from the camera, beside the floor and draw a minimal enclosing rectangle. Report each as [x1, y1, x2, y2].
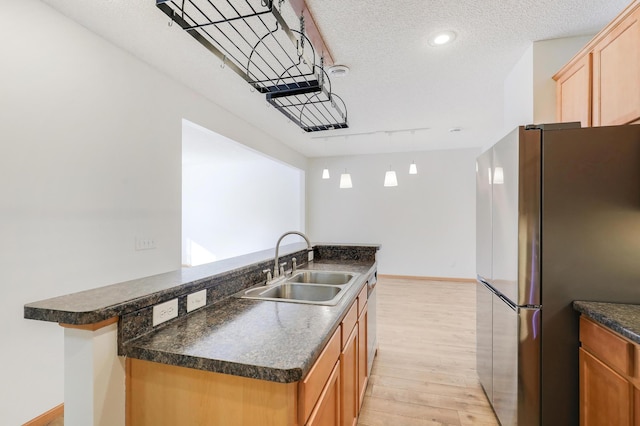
[340, 327, 358, 426]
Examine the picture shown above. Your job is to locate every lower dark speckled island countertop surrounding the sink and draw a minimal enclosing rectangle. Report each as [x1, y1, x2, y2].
[122, 261, 376, 383]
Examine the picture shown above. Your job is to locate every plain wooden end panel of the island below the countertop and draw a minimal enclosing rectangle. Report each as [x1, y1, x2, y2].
[127, 358, 298, 426]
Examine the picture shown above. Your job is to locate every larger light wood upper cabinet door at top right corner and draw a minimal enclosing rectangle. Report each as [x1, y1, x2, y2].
[593, 9, 640, 126]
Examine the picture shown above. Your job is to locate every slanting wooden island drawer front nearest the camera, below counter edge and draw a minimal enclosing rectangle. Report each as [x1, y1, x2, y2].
[299, 327, 341, 424]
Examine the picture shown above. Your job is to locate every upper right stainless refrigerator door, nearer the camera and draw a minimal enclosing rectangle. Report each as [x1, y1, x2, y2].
[490, 127, 541, 306]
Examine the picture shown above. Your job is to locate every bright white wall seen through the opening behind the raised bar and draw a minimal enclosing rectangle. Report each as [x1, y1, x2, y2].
[182, 121, 305, 266]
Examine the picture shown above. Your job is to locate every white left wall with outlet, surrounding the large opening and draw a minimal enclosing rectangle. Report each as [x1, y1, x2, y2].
[0, 0, 306, 425]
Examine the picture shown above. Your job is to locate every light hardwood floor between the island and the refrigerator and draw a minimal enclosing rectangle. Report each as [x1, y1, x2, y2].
[358, 278, 498, 426]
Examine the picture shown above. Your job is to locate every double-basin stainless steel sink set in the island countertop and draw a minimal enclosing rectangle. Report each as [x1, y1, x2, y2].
[239, 270, 360, 305]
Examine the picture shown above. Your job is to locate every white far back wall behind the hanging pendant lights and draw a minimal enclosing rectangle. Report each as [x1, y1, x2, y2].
[307, 149, 479, 278]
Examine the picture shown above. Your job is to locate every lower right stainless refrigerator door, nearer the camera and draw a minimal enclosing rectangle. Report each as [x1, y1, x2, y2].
[492, 295, 542, 426]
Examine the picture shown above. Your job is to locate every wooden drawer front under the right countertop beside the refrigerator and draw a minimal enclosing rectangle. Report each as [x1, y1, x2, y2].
[580, 316, 634, 375]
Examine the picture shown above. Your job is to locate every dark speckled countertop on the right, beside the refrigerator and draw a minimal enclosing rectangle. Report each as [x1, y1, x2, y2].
[573, 301, 640, 344]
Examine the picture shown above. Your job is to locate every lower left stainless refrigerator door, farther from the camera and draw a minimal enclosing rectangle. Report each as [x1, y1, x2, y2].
[476, 281, 494, 401]
